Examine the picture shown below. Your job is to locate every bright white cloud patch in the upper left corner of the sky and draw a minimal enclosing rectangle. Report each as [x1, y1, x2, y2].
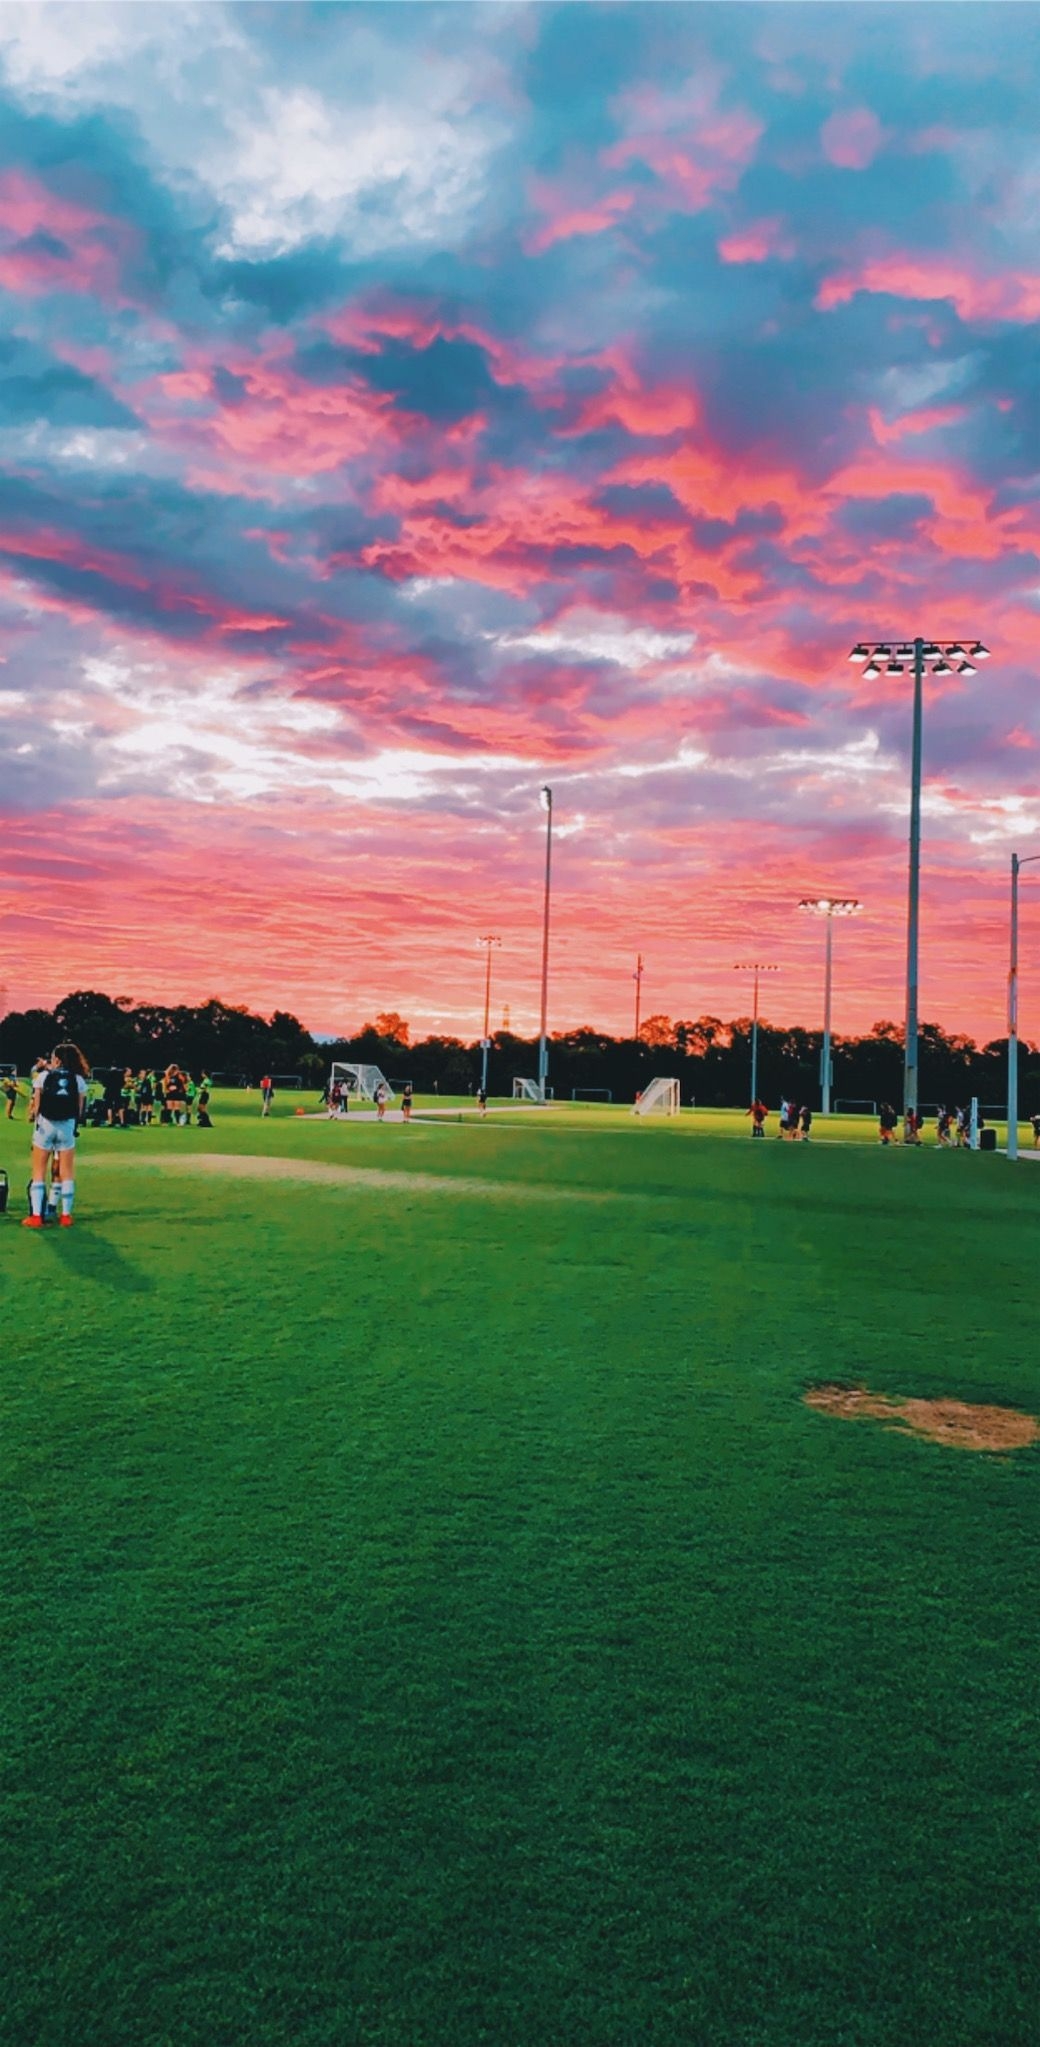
[0, 0, 510, 258]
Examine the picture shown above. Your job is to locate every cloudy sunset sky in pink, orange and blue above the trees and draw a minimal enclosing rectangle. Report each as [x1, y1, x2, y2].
[0, 0, 1040, 1040]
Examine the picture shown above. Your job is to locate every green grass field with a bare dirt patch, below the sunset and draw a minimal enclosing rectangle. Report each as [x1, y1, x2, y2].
[0, 1097, 1040, 2047]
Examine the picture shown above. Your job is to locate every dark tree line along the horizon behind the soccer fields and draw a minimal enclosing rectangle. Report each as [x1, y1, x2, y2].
[0, 989, 1040, 1114]
